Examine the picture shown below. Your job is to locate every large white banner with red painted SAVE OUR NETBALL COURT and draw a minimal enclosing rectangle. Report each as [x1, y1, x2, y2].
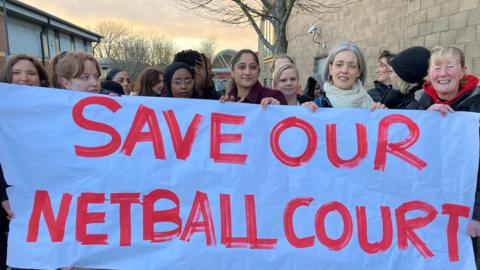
[0, 84, 479, 269]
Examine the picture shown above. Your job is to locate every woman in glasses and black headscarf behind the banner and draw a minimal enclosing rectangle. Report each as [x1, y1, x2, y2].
[165, 62, 195, 98]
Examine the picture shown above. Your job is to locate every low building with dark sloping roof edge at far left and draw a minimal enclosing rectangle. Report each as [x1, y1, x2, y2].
[0, 0, 102, 64]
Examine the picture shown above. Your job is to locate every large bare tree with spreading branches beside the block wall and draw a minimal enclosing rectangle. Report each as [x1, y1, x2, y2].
[178, 0, 361, 55]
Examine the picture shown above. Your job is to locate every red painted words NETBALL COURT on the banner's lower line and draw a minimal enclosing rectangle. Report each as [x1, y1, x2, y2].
[27, 189, 470, 261]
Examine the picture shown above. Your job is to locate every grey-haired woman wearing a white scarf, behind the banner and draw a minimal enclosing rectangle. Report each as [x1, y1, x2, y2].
[303, 42, 385, 111]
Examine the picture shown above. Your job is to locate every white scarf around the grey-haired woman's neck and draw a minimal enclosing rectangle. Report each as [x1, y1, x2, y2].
[323, 80, 373, 108]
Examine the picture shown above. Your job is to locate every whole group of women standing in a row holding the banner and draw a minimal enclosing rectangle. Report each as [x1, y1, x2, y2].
[0, 42, 480, 266]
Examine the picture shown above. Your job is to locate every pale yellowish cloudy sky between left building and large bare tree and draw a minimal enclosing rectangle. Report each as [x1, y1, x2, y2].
[21, 0, 258, 52]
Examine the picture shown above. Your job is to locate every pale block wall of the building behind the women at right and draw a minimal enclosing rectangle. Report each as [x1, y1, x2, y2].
[259, 0, 480, 87]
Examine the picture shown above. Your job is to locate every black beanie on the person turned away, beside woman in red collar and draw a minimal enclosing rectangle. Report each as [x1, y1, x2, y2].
[388, 46, 430, 83]
